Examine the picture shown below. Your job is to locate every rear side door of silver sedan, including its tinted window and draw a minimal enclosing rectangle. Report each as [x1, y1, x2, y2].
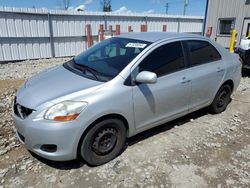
[185, 40, 225, 110]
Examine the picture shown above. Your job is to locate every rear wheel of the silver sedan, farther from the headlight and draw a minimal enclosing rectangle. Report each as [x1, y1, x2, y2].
[210, 84, 232, 114]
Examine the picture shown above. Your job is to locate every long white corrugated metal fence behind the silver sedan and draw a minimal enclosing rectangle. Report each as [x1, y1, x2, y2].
[0, 7, 203, 61]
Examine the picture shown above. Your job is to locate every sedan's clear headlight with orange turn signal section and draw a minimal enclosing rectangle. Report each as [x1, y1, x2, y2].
[44, 101, 88, 121]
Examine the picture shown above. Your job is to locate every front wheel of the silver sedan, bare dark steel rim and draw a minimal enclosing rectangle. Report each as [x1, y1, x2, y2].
[79, 119, 126, 166]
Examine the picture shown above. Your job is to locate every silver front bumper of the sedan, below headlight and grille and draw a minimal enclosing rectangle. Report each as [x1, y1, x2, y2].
[12, 113, 82, 161]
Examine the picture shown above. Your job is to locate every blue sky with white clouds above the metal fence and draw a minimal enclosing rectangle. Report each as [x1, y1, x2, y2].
[0, 0, 206, 16]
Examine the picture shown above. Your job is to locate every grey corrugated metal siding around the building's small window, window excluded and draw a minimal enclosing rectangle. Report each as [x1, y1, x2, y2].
[206, 0, 250, 48]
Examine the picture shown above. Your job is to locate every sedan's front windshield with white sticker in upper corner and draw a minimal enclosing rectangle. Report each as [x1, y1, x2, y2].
[64, 37, 150, 81]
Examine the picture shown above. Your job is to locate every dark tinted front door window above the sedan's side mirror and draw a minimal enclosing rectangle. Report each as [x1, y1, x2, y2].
[139, 42, 185, 76]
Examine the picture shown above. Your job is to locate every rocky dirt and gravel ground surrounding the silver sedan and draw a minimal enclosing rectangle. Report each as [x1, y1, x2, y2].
[0, 59, 250, 188]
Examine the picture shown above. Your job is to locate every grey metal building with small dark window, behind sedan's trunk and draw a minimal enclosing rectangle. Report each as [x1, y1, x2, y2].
[205, 0, 250, 48]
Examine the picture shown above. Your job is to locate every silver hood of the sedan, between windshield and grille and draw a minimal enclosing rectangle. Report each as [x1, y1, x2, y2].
[16, 65, 103, 109]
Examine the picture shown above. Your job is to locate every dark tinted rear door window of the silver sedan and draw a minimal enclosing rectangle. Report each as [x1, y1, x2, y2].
[186, 40, 221, 66]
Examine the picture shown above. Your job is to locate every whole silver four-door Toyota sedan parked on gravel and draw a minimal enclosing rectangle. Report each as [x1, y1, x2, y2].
[13, 33, 241, 165]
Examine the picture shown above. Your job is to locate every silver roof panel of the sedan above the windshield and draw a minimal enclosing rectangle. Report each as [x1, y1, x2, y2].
[118, 32, 205, 43]
